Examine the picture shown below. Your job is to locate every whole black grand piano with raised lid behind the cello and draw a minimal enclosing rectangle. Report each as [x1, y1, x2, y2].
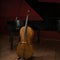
[7, 0, 60, 49]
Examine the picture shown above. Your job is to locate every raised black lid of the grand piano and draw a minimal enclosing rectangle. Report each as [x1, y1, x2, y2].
[25, 0, 60, 20]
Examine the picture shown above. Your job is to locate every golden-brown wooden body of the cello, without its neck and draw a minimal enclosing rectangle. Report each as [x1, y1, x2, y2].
[17, 27, 34, 59]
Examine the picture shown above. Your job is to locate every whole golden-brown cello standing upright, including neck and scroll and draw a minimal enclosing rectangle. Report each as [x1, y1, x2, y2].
[17, 10, 34, 60]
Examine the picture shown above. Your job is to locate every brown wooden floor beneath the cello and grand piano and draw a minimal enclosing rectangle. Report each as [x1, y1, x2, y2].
[0, 35, 60, 60]
